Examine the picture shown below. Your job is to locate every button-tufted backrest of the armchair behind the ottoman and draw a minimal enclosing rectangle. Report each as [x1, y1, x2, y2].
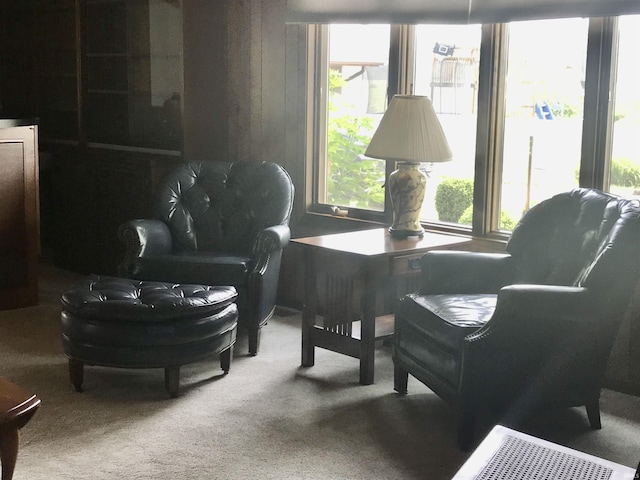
[154, 161, 294, 254]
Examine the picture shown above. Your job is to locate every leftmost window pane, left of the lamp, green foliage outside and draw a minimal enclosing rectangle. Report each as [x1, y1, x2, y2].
[319, 25, 390, 212]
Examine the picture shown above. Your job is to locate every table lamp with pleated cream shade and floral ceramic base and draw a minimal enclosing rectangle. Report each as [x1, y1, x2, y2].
[365, 95, 452, 238]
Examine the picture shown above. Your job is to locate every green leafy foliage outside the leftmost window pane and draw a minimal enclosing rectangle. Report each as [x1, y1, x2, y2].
[327, 69, 385, 210]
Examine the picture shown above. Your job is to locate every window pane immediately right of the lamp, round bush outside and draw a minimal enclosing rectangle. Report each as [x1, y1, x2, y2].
[413, 25, 481, 227]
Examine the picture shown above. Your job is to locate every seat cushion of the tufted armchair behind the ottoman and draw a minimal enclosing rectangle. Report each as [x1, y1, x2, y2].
[131, 252, 253, 286]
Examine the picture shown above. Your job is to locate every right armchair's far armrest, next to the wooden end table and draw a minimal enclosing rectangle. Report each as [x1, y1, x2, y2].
[420, 250, 515, 294]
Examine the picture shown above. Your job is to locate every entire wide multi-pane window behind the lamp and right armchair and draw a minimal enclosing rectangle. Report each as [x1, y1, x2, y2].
[310, 16, 640, 237]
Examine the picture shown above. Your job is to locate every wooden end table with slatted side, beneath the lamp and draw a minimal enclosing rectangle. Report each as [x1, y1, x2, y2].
[291, 228, 471, 385]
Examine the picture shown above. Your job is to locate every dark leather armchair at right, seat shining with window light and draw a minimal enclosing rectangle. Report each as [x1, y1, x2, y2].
[393, 189, 640, 450]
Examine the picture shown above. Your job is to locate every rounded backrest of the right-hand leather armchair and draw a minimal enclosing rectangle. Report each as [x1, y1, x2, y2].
[507, 188, 640, 294]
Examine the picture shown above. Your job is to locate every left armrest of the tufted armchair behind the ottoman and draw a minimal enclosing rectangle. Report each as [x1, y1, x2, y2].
[118, 219, 172, 274]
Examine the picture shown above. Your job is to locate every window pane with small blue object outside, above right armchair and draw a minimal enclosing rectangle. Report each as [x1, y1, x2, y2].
[500, 19, 588, 230]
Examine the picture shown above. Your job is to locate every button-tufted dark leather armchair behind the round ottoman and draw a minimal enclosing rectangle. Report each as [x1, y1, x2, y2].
[118, 161, 294, 355]
